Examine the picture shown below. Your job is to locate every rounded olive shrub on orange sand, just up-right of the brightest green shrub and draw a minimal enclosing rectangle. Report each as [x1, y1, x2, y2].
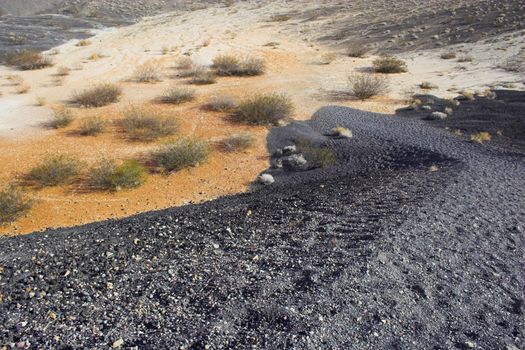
[151, 139, 210, 172]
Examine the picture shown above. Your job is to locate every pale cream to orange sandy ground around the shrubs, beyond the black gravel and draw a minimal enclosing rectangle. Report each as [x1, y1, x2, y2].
[0, 1, 525, 234]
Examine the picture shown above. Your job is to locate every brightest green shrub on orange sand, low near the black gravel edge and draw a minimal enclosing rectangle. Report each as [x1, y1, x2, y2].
[89, 159, 146, 191]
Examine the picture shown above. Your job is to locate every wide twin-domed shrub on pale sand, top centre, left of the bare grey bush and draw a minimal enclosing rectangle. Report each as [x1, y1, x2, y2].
[212, 54, 265, 76]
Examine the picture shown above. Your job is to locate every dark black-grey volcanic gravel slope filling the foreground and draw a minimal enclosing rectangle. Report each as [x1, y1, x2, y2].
[0, 93, 525, 350]
